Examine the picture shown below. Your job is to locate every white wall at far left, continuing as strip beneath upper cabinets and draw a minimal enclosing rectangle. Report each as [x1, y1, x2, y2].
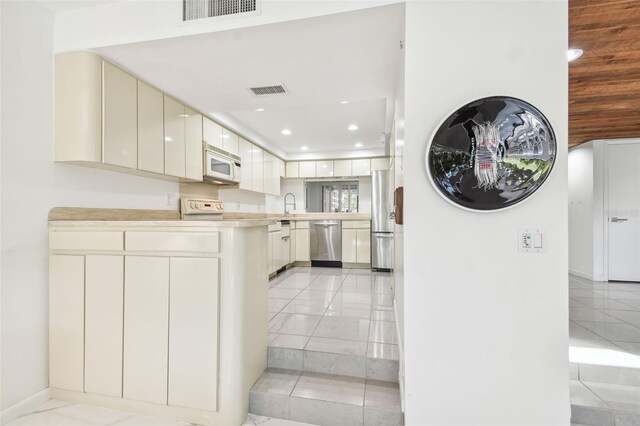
[0, 1, 178, 411]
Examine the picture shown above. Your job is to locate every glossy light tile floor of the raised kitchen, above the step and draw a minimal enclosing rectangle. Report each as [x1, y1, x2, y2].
[269, 267, 399, 360]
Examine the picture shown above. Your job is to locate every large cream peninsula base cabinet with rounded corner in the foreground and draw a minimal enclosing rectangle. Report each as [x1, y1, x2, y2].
[49, 225, 264, 426]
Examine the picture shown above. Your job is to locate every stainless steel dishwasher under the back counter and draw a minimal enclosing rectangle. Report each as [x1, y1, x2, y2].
[309, 220, 342, 267]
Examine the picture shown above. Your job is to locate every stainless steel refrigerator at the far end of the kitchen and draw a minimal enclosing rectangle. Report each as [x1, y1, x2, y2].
[371, 170, 394, 270]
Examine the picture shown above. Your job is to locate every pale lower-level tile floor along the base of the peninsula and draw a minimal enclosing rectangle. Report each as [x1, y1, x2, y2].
[6, 399, 312, 426]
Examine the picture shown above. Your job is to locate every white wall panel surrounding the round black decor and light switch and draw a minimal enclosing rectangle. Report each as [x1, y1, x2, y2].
[404, 0, 570, 426]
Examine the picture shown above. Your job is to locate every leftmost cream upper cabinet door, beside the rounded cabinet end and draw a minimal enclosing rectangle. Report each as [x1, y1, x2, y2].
[102, 61, 138, 169]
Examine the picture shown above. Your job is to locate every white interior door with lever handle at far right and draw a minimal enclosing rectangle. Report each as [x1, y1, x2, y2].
[607, 144, 640, 281]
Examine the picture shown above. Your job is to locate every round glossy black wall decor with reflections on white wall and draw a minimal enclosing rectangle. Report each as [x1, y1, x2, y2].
[426, 96, 556, 211]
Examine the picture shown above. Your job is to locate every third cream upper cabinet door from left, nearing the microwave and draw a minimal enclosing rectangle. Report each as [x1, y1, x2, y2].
[164, 96, 186, 177]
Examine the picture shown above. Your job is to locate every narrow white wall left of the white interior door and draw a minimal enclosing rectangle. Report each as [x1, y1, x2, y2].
[568, 142, 594, 279]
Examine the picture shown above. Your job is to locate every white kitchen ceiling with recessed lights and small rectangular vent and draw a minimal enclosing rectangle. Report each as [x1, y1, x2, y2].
[96, 5, 404, 157]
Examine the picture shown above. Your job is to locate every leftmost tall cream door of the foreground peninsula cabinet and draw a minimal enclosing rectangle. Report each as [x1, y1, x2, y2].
[49, 255, 84, 392]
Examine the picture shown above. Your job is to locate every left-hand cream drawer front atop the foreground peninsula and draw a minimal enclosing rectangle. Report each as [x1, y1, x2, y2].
[49, 231, 124, 250]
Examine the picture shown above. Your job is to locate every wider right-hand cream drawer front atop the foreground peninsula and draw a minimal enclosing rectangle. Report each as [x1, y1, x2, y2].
[125, 231, 220, 253]
